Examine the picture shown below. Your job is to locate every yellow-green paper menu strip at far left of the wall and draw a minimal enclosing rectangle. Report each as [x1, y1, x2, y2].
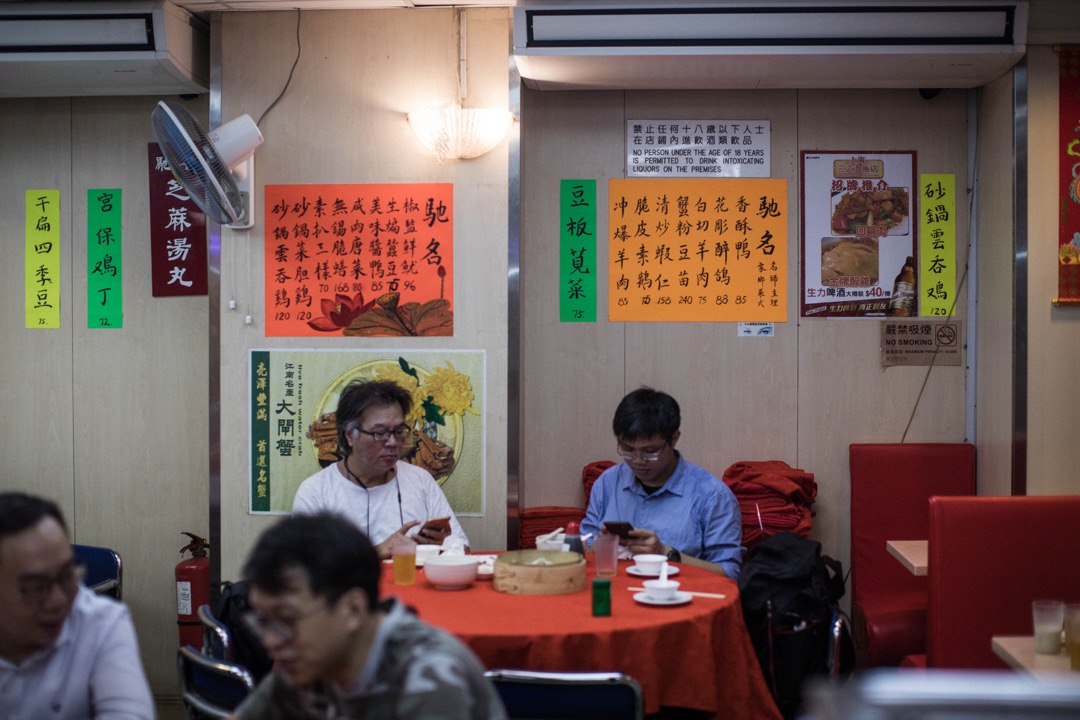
[24, 190, 60, 328]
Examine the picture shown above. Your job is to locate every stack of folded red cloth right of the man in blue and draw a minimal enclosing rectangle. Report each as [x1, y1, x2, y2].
[724, 460, 818, 549]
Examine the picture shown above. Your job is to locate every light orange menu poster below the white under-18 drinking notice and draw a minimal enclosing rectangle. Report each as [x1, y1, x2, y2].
[608, 178, 787, 323]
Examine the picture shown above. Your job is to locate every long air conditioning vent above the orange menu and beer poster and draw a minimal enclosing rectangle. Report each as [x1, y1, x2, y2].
[514, 0, 1028, 90]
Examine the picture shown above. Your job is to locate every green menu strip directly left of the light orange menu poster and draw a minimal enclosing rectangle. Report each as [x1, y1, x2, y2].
[558, 180, 596, 323]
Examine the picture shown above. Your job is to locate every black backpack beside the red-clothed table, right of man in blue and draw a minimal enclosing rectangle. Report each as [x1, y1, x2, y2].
[739, 532, 854, 720]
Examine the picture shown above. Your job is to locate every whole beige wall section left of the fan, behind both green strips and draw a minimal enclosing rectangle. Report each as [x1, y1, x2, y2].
[0, 92, 208, 695]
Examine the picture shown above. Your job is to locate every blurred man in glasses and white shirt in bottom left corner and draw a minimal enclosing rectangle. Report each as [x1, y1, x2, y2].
[0, 492, 154, 720]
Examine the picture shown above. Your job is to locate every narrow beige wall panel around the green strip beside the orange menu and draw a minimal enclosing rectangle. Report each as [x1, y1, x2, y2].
[521, 89, 626, 507]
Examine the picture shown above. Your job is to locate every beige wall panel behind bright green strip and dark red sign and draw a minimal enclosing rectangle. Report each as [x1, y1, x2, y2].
[71, 97, 210, 693]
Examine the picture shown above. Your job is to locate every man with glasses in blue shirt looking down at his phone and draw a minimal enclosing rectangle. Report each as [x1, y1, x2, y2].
[581, 388, 743, 580]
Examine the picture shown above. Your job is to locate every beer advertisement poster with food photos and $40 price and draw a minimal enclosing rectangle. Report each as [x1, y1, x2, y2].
[800, 150, 919, 317]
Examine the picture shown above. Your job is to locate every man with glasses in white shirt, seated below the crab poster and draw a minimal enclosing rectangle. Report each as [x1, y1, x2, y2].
[293, 380, 469, 559]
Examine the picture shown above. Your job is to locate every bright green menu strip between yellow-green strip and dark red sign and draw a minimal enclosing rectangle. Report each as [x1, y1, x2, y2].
[86, 188, 124, 329]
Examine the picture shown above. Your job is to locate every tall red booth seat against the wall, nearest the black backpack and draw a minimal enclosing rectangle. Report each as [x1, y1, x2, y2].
[849, 443, 975, 667]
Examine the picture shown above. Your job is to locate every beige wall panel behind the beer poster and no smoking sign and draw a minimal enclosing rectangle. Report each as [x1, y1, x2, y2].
[798, 90, 968, 587]
